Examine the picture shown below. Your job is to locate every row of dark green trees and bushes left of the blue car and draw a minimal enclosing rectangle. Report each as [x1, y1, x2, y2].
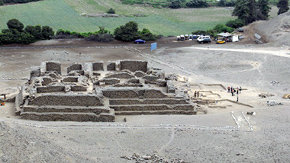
[0, 19, 159, 45]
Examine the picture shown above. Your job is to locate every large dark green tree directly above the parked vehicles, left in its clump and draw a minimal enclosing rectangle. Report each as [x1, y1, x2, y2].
[233, 0, 257, 24]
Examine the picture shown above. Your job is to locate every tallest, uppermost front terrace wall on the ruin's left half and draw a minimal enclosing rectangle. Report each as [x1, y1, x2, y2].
[29, 95, 103, 106]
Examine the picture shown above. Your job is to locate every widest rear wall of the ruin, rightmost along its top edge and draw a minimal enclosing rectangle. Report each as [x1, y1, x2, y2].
[120, 61, 148, 72]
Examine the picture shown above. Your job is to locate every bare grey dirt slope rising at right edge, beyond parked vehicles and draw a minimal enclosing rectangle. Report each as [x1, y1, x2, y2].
[252, 12, 290, 46]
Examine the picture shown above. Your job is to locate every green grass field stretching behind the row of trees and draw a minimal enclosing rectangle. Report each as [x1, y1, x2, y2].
[0, 0, 280, 36]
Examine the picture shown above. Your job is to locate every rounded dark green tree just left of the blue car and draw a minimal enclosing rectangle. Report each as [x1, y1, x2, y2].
[114, 21, 138, 42]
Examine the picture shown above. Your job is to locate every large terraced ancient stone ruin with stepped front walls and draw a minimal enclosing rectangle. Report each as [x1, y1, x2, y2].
[16, 61, 196, 122]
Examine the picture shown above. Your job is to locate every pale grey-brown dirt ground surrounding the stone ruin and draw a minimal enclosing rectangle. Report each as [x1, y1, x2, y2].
[0, 39, 290, 163]
